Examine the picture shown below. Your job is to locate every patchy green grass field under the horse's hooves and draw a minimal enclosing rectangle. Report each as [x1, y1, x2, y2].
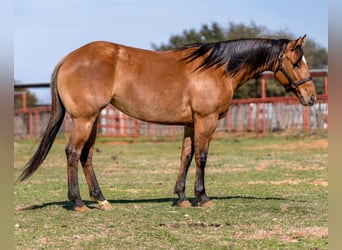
[14, 131, 328, 249]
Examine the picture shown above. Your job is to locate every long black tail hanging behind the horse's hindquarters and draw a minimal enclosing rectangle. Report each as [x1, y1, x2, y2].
[17, 60, 65, 181]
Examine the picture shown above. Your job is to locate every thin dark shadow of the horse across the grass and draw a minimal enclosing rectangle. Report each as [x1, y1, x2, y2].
[15, 195, 289, 212]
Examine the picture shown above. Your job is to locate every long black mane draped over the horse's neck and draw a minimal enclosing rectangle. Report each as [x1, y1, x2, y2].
[178, 39, 290, 76]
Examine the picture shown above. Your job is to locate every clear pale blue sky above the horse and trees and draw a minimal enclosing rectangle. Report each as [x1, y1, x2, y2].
[14, 0, 328, 104]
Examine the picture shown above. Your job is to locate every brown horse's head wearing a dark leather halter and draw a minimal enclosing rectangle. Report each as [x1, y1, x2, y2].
[274, 35, 316, 106]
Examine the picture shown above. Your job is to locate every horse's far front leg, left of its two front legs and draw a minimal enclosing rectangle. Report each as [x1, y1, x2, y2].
[174, 127, 194, 207]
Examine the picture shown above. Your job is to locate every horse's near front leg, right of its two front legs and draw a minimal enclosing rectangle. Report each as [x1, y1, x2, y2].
[194, 115, 218, 207]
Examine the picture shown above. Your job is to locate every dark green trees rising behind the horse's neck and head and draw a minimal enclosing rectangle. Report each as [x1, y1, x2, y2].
[152, 22, 328, 98]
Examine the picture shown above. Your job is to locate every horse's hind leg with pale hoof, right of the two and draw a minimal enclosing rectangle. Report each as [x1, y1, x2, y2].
[80, 119, 112, 210]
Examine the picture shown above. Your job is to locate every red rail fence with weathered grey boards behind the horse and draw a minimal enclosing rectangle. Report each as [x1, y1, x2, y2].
[14, 71, 328, 139]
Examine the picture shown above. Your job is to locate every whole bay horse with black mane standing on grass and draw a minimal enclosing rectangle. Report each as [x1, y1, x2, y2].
[18, 35, 316, 211]
